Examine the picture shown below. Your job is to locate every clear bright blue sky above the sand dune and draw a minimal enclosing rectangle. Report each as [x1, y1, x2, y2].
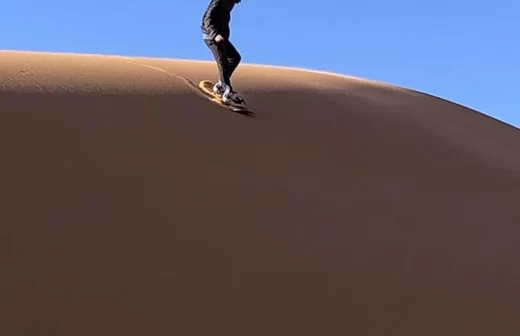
[0, 0, 520, 127]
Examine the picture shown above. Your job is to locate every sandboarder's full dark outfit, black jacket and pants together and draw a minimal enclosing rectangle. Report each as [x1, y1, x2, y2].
[201, 0, 241, 88]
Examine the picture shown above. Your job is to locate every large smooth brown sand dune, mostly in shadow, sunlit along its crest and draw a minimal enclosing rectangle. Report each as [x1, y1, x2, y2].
[0, 52, 520, 336]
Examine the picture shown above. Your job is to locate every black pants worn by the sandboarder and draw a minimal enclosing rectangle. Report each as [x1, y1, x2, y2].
[204, 40, 242, 89]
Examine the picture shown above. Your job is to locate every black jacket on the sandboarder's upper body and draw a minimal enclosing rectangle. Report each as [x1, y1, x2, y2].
[201, 0, 235, 40]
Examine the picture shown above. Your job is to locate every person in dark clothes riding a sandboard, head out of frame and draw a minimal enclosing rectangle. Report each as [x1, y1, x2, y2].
[201, 0, 245, 105]
